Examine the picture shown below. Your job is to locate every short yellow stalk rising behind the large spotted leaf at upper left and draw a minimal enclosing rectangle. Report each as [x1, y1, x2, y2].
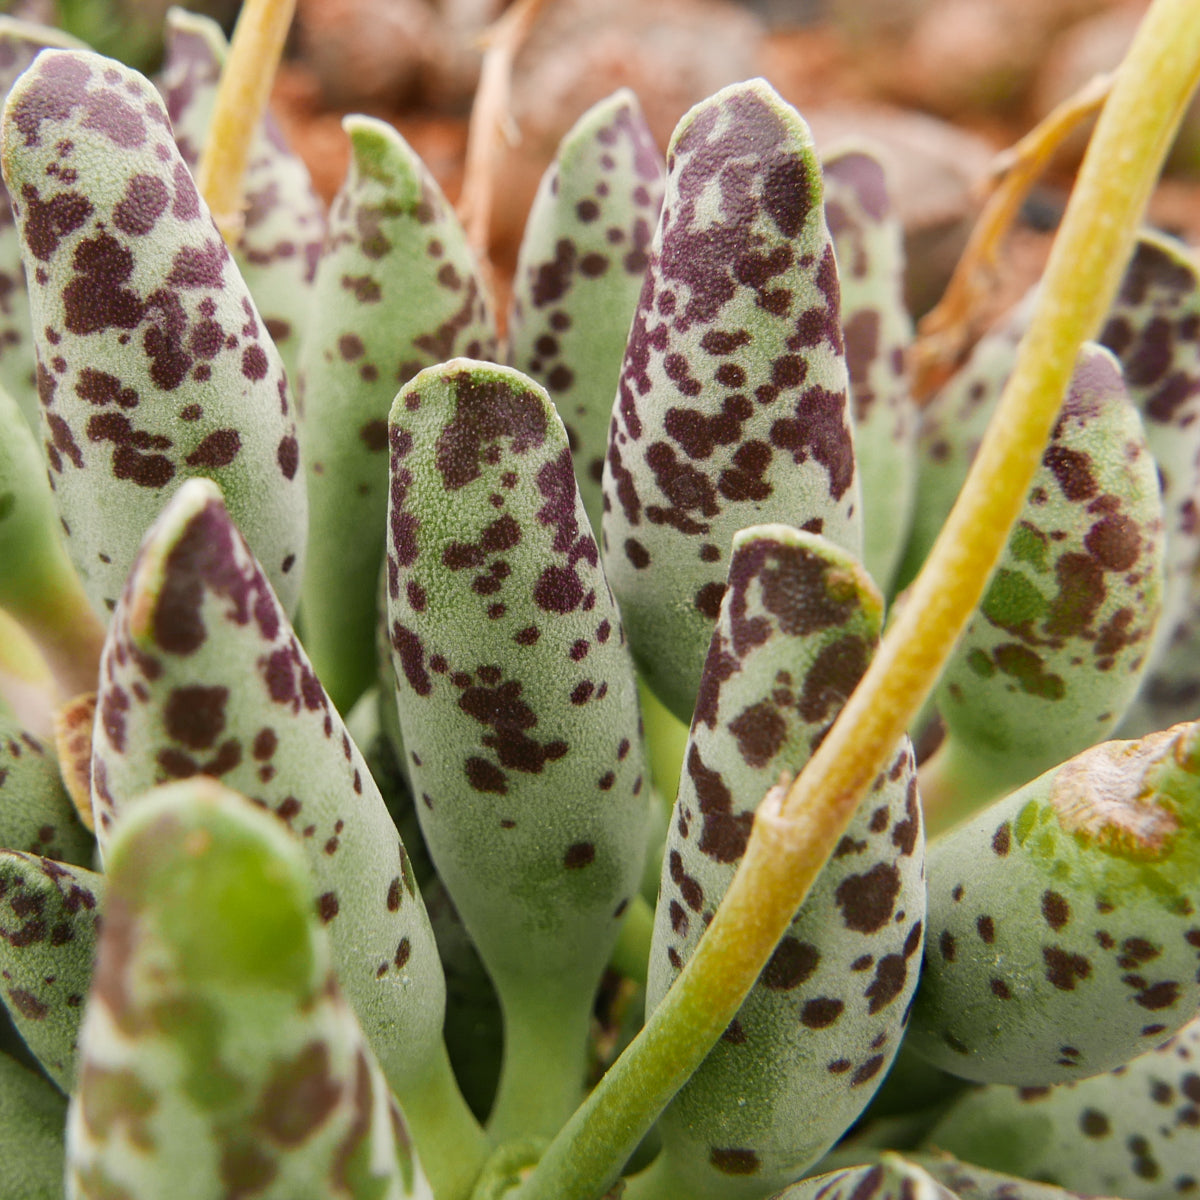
[196, 0, 295, 246]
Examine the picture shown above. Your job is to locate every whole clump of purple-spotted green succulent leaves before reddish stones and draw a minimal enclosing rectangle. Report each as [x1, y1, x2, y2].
[0, 0, 1200, 1200]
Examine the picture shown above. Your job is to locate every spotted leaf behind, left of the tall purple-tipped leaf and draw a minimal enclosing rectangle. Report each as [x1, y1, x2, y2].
[509, 90, 664, 535]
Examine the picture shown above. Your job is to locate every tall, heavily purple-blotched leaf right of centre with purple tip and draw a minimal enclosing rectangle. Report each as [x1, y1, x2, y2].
[604, 80, 862, 721]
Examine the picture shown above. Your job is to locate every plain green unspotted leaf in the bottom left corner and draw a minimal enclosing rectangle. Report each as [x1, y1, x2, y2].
[0, 1054, 67, 1200]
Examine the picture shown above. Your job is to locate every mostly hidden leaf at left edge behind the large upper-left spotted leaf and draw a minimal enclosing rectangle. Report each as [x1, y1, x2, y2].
[0, 16, 86, 430]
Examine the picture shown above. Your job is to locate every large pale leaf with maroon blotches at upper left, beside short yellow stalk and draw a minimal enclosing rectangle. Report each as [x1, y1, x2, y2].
[2, 50, 306, 608]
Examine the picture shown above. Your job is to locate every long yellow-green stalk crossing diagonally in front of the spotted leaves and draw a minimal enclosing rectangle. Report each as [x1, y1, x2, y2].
[516, 0, 1200, 1200]
